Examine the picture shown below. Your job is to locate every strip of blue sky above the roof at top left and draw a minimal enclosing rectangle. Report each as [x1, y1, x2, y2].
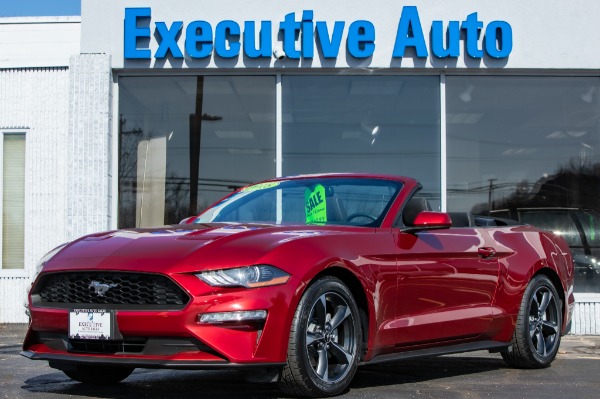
[0, 0, 81, 17]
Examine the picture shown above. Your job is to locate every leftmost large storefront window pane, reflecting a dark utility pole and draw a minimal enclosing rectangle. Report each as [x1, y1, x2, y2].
[118, 76, 275, 228]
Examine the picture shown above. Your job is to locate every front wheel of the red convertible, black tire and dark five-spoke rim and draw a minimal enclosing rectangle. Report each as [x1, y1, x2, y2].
[278, 276, 362, 397]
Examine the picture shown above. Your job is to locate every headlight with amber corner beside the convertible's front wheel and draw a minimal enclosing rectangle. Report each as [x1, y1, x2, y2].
[196, 265, 290, 288]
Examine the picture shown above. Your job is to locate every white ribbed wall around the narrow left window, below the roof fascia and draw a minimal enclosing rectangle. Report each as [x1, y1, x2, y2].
[0, 67, 69, 322]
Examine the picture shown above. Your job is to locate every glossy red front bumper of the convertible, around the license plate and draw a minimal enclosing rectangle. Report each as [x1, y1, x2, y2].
[21, 275, 298, 369]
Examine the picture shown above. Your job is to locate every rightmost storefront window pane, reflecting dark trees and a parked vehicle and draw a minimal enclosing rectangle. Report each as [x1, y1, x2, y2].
[446, 77, 600, 292]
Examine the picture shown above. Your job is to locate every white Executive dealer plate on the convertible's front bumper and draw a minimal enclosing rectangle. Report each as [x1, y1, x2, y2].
[69, 309, 114, 340]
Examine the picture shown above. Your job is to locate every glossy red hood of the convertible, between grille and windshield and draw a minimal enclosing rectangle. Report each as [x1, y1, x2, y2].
[44, 224, 356, 273]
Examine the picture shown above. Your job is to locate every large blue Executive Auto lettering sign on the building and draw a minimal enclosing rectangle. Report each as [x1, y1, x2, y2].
[124, 6, 513, 60]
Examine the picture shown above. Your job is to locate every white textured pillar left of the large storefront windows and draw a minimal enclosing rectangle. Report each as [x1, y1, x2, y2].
[66, 54, 113, 241]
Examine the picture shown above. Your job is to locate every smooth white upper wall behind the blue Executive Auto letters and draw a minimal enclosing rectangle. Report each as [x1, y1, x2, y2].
[81, 0, 600, 69]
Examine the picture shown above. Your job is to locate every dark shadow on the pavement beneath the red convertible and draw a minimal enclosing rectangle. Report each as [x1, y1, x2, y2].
[21, 357, 506, 399]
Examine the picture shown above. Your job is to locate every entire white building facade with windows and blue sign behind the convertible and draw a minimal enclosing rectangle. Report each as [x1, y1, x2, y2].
[0, 0, 600, 334]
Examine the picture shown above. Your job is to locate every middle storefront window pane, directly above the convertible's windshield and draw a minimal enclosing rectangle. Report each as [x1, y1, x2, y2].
[282, 76, 440, 207]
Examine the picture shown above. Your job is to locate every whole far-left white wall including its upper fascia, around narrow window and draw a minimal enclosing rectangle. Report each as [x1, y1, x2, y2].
[0, 17, 81, 323]
